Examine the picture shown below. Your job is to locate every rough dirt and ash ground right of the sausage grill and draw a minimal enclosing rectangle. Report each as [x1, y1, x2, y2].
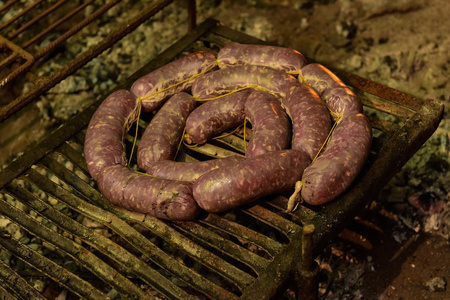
[213, 0, 450, 300]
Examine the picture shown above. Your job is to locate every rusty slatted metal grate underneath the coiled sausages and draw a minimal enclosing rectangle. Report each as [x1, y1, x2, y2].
[0, 20, 443, 299]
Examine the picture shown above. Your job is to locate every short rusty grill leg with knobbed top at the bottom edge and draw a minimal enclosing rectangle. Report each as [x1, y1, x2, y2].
[294, 224, 319, 300]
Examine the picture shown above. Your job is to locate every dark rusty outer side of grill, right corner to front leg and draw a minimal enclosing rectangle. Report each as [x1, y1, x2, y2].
[311, 100, 444, 256]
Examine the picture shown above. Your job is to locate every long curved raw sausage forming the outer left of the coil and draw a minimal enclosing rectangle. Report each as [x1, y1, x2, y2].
[84, 90, 200, 220]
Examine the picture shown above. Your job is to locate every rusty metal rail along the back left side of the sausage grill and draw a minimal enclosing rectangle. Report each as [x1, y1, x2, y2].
[0, 19, 218, 188]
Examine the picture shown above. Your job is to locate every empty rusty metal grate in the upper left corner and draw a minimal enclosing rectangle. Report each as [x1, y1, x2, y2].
[0, 0, 178, 122]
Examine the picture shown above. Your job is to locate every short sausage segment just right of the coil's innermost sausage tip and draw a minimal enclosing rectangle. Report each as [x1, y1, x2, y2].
[245, 90, 291, 158]
